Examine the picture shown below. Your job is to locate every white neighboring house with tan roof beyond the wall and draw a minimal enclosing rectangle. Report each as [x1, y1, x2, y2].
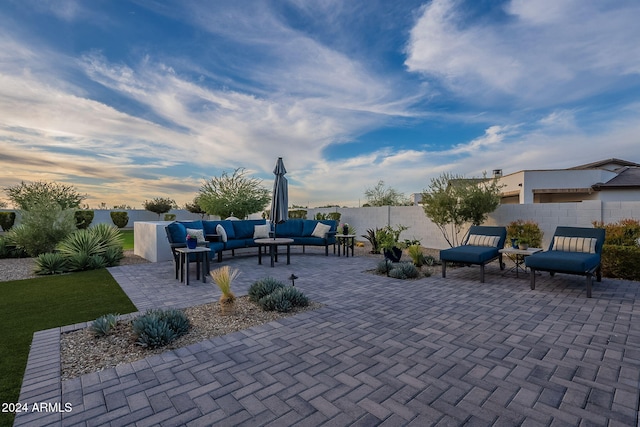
[494, 159, 640, 204]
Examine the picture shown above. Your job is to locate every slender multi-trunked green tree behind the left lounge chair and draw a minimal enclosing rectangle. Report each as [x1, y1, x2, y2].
[422, 173, 500, 247]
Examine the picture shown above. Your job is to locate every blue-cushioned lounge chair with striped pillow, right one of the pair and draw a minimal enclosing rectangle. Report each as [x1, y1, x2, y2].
[524, 227, 605, 298]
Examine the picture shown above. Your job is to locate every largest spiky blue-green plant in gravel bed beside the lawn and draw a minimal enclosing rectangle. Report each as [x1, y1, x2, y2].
[131, 310, 190, 348]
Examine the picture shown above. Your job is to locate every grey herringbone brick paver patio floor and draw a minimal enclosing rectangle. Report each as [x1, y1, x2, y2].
[15, 248, 640, 426]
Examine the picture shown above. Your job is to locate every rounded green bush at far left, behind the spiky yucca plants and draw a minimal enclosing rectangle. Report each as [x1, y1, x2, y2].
[8, 201, 76, 257]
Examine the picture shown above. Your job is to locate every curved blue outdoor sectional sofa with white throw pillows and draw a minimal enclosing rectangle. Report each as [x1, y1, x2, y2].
[167, 219, 337, 261]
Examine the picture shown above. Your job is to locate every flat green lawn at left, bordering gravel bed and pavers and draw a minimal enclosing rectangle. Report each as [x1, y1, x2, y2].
[0, 270, 137, 427]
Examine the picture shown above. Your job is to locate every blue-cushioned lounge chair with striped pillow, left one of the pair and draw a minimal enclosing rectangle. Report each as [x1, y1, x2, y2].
[440, 225, 507, 283]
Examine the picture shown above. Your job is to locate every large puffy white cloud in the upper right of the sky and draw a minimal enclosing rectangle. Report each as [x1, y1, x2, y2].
[405, 0, 640, 105]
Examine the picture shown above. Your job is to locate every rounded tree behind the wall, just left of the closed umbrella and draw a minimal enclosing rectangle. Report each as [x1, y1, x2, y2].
[197, 168, 271, 219]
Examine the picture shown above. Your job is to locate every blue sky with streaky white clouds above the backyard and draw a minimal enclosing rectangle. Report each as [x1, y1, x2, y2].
[0, 0, 640, 207]
